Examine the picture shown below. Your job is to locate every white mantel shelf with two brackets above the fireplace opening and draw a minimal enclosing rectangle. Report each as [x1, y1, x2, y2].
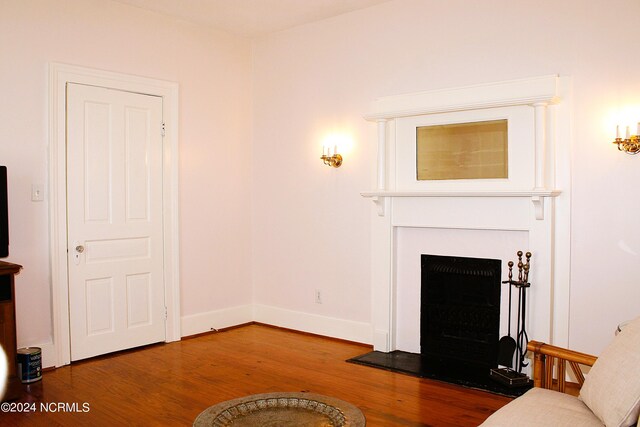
[360, 189, 562, 220]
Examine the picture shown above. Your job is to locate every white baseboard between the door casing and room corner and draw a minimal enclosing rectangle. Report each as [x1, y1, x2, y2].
[180, 305, 253, 337]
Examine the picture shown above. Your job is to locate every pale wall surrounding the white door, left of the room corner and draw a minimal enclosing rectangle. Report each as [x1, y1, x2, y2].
[0, 0, 251, 352]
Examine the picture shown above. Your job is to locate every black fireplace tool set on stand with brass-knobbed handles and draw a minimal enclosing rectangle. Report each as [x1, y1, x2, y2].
[489, 251, 531, 387]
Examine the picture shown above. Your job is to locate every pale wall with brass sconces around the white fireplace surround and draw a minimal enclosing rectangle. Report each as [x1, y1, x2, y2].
[252, 0, 640, 354]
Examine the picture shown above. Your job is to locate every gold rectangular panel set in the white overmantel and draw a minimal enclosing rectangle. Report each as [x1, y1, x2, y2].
[416, 120, 509, 181]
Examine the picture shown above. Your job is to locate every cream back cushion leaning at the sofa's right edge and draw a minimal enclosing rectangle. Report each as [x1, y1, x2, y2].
[580, 317, 640, 427]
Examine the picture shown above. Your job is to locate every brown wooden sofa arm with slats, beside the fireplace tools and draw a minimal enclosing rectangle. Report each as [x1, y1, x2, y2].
[527, 341, 597, 393]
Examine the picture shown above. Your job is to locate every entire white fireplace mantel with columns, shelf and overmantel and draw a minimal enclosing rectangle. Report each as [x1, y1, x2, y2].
[361, 76, 571, 351]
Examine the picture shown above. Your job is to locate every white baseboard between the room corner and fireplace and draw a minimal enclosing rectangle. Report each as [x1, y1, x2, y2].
[253, 304, 372, 344]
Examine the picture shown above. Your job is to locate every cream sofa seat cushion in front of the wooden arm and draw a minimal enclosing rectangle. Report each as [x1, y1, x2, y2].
[481, 388, 603, 427]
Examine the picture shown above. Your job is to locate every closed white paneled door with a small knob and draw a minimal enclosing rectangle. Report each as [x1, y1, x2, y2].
[67, 83, 166, 360]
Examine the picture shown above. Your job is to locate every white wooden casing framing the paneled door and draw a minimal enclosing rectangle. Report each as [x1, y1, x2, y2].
[49, 63, 181, 366]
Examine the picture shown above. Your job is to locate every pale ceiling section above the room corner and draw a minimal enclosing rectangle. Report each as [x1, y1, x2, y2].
[109, 0, 389, 38]
